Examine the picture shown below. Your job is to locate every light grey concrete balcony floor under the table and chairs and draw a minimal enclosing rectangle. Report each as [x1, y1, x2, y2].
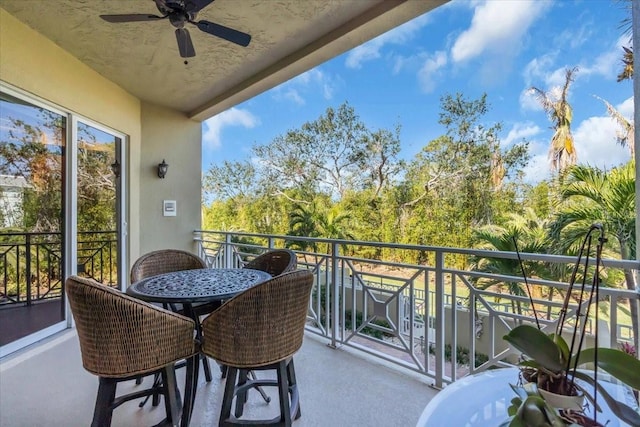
[0, 330, 437, 427]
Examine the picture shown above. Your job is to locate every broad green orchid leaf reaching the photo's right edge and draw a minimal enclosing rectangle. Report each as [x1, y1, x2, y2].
[577, 348, 640, 390]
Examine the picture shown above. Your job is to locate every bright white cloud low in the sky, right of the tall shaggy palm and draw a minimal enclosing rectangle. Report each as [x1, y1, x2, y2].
[573, 116, 631, 169]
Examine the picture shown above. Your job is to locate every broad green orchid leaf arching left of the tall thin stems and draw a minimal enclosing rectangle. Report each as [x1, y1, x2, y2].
[503, 325, 565, 372]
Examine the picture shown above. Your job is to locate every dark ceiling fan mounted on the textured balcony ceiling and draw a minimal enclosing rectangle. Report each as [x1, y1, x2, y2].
[100, 0, 251, 58]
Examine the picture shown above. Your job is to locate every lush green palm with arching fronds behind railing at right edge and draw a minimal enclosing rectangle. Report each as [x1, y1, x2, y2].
[551, 160, 640, 348]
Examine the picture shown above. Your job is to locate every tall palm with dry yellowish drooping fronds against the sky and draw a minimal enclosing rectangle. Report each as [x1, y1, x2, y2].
[530, 67, 578, 172]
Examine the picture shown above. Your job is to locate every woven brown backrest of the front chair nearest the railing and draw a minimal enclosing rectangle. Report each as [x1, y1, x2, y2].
[202, 270, 313, 368]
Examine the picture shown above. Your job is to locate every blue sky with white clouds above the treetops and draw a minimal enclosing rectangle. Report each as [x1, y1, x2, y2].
[202, 0, 633, 182]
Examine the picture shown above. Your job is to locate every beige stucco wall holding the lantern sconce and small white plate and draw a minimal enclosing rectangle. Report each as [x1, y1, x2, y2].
[139, 103, 202, 253]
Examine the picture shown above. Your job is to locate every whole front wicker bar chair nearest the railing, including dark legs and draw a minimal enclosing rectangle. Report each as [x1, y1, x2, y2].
[202, 270, 313, 426]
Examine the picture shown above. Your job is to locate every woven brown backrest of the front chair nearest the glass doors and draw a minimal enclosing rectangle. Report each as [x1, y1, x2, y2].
[65, 276, 195, 378]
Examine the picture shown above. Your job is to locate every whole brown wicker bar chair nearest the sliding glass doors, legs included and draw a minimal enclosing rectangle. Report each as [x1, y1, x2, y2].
[65, 276, 197, 427]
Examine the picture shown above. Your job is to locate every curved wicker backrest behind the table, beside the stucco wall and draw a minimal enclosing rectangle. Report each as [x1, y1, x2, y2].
[131, 249, 207, 283]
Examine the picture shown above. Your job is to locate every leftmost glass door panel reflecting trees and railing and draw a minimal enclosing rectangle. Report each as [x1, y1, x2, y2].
[0, 92, 67, 348]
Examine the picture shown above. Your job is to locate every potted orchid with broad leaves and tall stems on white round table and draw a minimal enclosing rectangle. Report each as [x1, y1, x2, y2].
[504, 224, 640, 427]
